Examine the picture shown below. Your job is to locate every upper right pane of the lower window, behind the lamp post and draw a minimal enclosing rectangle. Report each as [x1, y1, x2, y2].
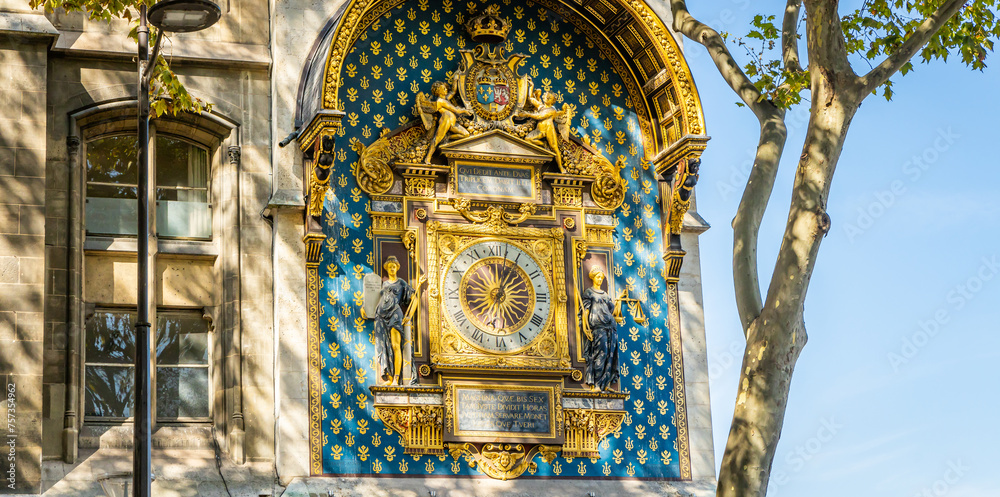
[156, 313, 208, 365]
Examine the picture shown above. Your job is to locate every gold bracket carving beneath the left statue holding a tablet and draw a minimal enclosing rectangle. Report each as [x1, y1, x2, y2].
[375, 405, 444, 454]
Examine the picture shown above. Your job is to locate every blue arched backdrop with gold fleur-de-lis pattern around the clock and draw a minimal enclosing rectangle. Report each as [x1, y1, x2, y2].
[319, 0, 680, 479]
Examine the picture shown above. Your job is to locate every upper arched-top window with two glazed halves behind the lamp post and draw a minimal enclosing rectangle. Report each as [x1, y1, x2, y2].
[85, 135, 212, 239]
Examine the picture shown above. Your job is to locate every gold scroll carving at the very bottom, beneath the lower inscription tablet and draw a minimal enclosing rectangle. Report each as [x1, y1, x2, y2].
[448, 443, 560, 480]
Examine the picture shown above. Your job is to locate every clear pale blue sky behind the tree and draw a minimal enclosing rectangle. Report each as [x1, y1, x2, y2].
[685, 0, 1000, 497]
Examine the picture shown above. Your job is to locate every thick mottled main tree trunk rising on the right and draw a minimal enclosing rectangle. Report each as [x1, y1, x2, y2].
[718, 43, 859, 497]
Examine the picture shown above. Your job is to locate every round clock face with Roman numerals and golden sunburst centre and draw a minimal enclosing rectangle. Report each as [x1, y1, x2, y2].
[441, 240, 552, 353]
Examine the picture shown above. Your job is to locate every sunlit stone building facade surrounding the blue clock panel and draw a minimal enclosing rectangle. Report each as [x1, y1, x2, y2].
[0, 0, 715, 496]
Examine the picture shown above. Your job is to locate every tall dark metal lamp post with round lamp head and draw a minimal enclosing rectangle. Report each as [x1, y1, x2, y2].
[132, 0, 222, 497]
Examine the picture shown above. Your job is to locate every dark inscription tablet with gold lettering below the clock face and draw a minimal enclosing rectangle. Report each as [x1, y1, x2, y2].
[455, 386, 553, 437]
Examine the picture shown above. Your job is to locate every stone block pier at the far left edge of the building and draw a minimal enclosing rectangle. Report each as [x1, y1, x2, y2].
[0, 7, 59, 494]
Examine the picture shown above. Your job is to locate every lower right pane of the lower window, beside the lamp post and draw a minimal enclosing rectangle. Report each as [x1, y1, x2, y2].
[156, 367, 208, 418]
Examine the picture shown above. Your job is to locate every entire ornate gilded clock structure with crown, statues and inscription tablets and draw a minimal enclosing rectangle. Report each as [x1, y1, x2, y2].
[354, 7, 646, 479]
